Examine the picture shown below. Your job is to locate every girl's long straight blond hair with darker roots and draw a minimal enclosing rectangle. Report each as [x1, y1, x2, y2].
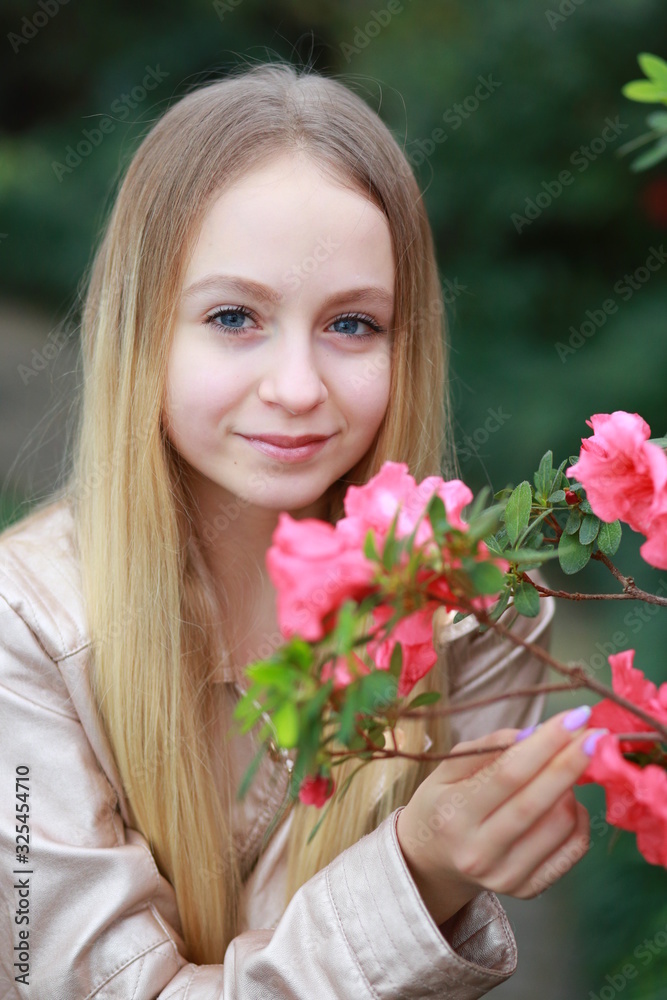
[2, 62, 456, 963]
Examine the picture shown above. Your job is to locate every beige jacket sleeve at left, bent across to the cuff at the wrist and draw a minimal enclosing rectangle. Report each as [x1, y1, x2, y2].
[0, 598, 516, 1000]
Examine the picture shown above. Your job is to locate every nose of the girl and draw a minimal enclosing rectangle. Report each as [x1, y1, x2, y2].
[258, 337, 329, 414]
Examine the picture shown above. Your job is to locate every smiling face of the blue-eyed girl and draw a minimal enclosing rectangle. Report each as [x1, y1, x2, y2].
[164, 154, 395, 514]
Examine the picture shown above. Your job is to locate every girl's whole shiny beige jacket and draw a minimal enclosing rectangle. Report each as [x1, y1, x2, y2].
[0, 504, 553, 1000]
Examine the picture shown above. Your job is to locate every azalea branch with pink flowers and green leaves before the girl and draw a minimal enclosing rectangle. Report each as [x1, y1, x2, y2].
[235, 411, 667, 864]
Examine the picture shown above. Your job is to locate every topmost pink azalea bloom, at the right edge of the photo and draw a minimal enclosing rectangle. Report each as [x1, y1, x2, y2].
[567, 410, 667, 540]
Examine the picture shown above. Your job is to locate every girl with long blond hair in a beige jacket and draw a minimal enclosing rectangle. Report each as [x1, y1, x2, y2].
[0, 64, 588, 1000]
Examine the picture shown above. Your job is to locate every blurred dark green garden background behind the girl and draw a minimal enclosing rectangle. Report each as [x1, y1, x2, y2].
[0, 0, 667, 1000]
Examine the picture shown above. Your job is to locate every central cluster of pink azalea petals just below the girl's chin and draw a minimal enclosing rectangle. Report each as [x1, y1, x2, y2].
[267, 462, 507, 692]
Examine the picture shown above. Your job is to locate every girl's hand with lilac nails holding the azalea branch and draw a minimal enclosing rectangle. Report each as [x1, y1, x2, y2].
[396, 708, 599, 925]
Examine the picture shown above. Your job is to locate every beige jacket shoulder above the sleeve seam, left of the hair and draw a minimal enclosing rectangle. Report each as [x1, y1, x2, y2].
[0, 500, 89, 661]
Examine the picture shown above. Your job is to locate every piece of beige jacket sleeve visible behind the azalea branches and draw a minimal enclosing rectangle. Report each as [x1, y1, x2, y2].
[438, 597, 556, 744]
